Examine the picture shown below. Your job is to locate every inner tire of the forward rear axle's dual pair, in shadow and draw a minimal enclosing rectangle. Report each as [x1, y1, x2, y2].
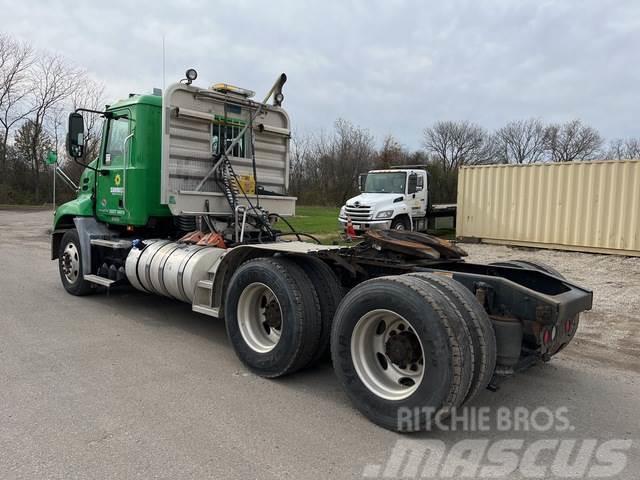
[294, 256, 344, 365]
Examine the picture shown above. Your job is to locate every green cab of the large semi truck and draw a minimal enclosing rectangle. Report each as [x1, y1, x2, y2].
[54, 95, 171, 234]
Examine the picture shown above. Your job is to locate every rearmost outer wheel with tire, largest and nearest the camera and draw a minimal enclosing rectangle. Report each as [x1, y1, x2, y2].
[331, 275, 472, 431]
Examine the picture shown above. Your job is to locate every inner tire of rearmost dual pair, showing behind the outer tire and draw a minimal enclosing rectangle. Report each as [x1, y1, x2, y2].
[409, 273, 497, 403]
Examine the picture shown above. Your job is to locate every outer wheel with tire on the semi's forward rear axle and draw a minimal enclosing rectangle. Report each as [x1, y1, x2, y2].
[225, 258, 322, 378]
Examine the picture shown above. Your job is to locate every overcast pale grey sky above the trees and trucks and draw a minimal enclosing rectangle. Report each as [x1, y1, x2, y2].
[0, 0, 640, 148]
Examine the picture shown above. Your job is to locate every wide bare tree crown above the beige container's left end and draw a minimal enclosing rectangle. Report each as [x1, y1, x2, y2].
[423, 121, 495, 173]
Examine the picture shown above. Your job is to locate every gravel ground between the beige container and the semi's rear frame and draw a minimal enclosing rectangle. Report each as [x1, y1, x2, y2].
[462, 244, 640, 371]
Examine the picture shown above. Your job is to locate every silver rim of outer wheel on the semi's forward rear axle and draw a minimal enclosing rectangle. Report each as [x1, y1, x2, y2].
[238, 282, 282, 353]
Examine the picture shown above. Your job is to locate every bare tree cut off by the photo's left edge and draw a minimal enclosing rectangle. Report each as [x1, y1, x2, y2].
[0, 34, 33, 173]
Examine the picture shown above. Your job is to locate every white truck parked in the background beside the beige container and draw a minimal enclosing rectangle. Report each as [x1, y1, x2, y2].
[338, 166, 456, 232]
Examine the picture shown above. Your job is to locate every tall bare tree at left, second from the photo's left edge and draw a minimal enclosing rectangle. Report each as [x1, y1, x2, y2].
[29, 54, 84, 202]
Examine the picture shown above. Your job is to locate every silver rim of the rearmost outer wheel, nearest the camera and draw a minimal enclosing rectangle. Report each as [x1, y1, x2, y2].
[351, 309, 424, 400]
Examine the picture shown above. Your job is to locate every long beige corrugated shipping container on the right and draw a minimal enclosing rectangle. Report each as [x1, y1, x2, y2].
[456, 160, 640, 256]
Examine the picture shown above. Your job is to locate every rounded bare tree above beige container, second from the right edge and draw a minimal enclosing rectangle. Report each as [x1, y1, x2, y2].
[544, 120, 604, 162]
